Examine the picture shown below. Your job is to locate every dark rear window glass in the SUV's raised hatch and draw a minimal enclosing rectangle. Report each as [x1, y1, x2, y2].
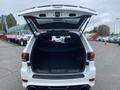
[27, 15, 90, 29]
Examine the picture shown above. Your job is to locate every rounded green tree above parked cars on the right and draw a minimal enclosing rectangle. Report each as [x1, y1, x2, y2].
[97, 25, 110, 36]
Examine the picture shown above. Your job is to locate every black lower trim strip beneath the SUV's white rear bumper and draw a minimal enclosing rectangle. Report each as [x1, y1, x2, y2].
[27, 85, 90, 90]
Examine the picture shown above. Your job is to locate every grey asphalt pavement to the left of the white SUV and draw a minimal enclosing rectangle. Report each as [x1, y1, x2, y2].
[0, 41, 24, 90]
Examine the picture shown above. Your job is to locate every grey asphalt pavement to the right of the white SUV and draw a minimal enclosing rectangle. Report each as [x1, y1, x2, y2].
[90, 42, 120, 90]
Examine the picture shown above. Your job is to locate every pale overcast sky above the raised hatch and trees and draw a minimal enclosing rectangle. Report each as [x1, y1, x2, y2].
[0, 0, 120, 33]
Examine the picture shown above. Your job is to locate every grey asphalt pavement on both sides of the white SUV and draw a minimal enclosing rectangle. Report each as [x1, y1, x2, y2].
[0, 41, 120, 90]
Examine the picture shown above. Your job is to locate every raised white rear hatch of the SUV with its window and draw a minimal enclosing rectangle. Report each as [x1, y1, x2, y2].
[18, 5, 96, 36]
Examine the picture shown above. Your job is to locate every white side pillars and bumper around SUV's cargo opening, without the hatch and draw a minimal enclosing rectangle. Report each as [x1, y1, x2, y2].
[21, 35, 96, 88]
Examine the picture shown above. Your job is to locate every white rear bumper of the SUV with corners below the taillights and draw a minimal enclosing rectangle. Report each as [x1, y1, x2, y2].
[21, 62, 96, 88]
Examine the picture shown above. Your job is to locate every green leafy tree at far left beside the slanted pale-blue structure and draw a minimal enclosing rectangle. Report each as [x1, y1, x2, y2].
[6, 14, 17, 28]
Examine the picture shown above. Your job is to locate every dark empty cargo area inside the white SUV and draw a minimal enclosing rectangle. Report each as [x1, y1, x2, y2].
[30, 32, 86, 74]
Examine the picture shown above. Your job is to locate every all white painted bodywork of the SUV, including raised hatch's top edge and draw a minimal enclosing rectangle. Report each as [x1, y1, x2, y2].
[19, 6, 96, 88]
